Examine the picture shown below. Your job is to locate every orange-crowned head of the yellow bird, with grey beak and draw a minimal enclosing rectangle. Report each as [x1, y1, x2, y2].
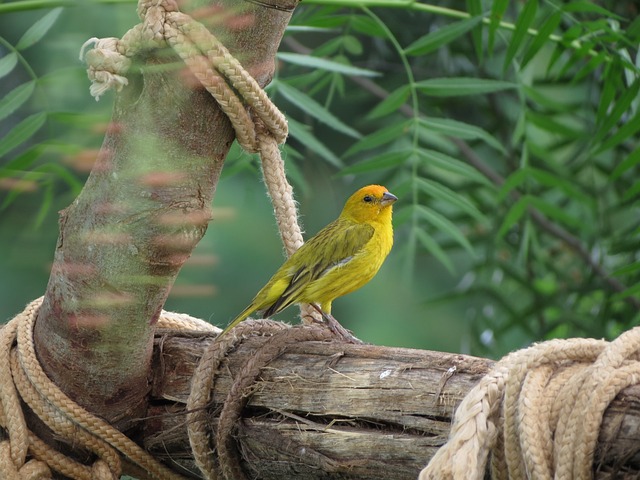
[340, 185, 398, 222]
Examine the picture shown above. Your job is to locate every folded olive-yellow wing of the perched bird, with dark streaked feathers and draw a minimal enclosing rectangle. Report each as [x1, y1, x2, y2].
[264, 219, 374, 317]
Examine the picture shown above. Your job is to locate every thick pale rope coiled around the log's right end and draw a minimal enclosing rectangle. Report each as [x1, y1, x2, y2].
[419, 327, 640, 480]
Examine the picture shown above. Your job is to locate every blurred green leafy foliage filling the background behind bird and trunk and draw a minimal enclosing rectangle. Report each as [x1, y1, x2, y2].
[0, 0, 640, 356]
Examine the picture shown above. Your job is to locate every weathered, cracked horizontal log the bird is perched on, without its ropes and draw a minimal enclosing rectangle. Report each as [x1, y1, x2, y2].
[144, 334, 640, 480]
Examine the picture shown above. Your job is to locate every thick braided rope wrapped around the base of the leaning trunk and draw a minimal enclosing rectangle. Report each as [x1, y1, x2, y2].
[0, 298, 214, 480]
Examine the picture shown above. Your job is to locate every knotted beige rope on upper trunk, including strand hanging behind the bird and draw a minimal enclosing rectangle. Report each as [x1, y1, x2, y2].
[80, 0, 303, 255]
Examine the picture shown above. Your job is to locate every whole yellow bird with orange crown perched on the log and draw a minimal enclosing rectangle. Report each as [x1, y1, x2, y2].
[220, 185, 397, 336]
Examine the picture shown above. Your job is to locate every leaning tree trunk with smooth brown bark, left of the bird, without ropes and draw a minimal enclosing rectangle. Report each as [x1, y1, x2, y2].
[35, 0, 297, 430]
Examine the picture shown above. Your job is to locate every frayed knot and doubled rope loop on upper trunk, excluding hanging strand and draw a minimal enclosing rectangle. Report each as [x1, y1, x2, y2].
[81, 0, 287, 153]
